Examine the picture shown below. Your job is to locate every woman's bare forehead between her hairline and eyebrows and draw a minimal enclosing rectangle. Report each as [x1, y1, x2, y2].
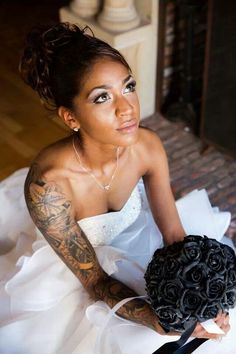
[82, 59, 130, 91]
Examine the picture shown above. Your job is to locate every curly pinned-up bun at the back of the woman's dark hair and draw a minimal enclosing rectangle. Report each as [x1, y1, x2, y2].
[19, 23, 87, 101]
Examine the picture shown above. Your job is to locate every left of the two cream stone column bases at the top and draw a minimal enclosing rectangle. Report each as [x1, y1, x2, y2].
[70, 0, 100, 19]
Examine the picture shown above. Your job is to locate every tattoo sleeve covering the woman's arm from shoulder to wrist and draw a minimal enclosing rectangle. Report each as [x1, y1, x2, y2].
[25, 164, 164, 333]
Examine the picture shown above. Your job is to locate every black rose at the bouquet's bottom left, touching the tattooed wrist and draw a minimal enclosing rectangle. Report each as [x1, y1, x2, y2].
[155, 306, 183, 329]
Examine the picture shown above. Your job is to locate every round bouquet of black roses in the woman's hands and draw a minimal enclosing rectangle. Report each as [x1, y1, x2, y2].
[144, 236, 236, 332]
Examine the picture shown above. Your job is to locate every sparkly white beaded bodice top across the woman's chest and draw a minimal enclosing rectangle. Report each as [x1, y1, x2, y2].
[78, 185, 141, 247]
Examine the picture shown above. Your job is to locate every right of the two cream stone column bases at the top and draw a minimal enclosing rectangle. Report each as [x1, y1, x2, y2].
[98, 0, 140, 32]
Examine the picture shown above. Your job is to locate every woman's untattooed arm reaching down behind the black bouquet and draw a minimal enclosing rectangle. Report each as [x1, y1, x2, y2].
[143, 130, 185, 244]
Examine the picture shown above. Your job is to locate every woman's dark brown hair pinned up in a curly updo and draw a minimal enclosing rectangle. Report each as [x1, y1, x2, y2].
[19, 23, 131, 109]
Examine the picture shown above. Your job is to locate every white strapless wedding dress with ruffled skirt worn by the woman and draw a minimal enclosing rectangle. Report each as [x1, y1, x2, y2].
[0, 169, 236, 354]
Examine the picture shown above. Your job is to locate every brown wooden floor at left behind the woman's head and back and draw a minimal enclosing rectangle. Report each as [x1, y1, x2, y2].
[0, 0, 68, 179]
